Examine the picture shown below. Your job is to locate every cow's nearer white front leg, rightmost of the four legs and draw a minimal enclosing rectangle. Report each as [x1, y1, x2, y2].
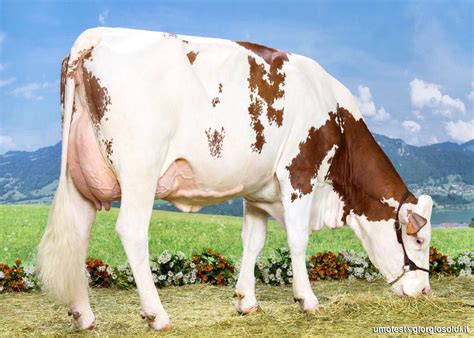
[285, 198, 320, 312]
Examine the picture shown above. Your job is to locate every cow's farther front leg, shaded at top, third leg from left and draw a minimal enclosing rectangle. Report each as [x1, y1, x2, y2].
[235, 201, 268, 314]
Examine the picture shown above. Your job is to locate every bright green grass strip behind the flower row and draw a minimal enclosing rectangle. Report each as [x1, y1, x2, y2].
[0, 205, 474, 265]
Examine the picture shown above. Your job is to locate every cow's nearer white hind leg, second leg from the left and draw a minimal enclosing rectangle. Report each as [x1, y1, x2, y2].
[116, 181, 171, 330]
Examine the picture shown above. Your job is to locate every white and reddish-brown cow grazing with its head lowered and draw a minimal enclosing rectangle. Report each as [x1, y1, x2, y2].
[38, 27, 433, 330]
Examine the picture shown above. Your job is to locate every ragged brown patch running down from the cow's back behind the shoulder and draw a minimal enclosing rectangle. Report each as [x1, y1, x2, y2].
[237, 41, 288, 153]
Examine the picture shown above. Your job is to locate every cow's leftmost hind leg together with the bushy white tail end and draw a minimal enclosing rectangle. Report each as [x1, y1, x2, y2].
[38, 172, 96, 329]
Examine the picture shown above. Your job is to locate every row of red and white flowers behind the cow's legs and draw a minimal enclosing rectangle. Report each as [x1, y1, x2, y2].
[0, 247, 474, 293]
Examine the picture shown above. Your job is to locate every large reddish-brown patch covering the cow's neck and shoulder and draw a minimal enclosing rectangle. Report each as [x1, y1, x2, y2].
[286, 105, 417, 221]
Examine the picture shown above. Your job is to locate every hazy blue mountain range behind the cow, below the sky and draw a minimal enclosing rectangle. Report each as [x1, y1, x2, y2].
[0, 134, 474, 215]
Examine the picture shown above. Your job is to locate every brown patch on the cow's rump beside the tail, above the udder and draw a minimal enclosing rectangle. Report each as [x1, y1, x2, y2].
[82, 67, 112, 128]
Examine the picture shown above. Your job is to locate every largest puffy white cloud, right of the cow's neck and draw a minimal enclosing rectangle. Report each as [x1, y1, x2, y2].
[410, 78, 466, 117]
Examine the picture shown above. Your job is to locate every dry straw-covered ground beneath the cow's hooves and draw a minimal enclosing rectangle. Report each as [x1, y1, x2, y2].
[0, 278, 474, 336]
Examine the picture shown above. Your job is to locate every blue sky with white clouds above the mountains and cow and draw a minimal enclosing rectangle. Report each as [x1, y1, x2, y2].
[0, 0, 474, 154]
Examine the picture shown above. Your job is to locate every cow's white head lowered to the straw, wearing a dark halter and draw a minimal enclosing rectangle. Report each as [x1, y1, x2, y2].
[348, 195, 433, 296]
